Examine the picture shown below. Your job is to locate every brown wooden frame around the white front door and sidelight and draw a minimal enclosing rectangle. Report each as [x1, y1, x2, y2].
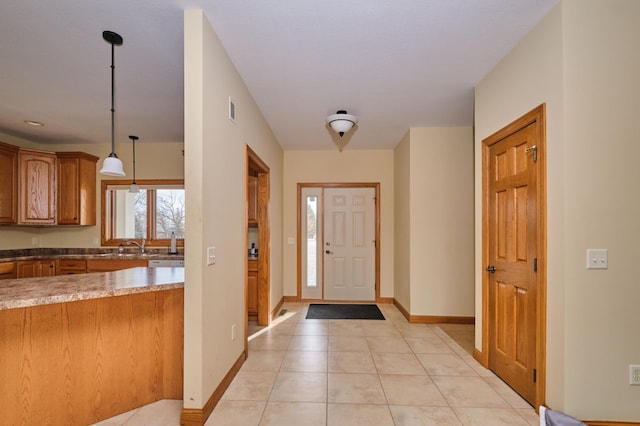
[295, 182, 382, 303]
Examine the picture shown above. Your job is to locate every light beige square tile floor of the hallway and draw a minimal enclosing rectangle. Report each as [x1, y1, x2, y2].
[97, 303, 539, 426]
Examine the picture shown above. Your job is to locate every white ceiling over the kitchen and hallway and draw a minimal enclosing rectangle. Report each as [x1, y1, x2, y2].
[0, 0, 558, 149]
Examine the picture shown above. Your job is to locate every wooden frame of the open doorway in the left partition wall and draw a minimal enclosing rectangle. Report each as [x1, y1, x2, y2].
[244, 145, 271, 340]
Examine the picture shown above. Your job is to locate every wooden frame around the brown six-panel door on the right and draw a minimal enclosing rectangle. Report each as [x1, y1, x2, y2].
[482, 103, 547, 411]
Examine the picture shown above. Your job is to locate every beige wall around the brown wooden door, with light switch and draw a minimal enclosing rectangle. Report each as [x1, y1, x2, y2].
[476, 0, 640, 421]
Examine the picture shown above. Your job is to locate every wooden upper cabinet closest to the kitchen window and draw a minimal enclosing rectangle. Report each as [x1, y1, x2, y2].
[56, 152, 98, 226]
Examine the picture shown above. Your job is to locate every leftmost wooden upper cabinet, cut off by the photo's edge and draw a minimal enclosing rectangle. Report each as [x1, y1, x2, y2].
[0, 142, 18, 223]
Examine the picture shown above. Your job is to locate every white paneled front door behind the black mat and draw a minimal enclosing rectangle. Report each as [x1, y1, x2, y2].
[323, 188, 376, 301]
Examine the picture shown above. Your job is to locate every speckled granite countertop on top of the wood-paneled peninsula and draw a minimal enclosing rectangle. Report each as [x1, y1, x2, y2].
[0, 268, 184, 311]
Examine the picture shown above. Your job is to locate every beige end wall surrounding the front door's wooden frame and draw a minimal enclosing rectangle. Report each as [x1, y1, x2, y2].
[283, 150, 394, 297]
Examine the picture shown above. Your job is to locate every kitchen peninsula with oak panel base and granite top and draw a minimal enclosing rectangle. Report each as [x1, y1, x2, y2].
[0, 267, 184, 424]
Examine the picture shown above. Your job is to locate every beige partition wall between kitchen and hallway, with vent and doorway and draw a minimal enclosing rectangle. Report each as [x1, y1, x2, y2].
[184, 10, 282, 408]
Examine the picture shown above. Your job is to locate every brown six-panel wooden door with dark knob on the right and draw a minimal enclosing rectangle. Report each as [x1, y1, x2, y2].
[485, 114, 540, 406]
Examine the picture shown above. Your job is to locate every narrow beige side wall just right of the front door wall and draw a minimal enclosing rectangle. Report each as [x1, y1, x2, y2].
[393, 132, 411, 310]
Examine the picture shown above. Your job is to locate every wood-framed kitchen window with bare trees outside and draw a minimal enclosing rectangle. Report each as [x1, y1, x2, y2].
[102, 180, 185, 246]
